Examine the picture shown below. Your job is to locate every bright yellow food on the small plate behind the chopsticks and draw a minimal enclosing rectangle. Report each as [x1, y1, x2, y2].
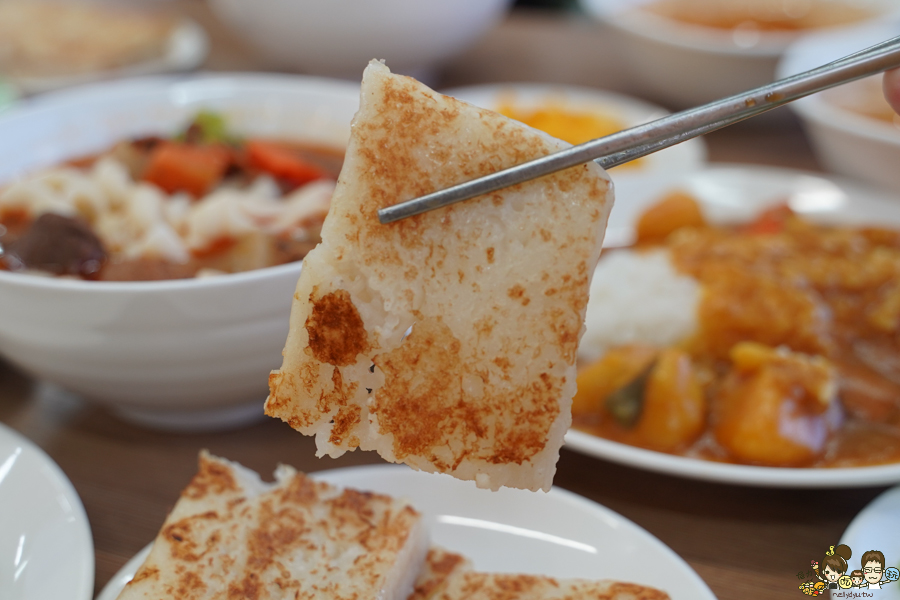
[496, 98, 644, 168]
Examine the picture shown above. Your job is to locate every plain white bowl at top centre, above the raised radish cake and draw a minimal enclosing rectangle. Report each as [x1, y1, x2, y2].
[209, 0, 511, 79]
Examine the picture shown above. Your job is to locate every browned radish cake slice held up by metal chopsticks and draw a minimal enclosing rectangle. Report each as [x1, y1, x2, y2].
[266, 62, 612, 490]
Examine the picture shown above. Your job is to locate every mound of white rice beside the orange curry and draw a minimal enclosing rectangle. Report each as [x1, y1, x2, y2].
[578, 250, 700, 361]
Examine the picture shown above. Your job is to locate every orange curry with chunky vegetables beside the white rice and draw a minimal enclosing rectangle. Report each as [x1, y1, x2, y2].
[573, 192, 900, 467]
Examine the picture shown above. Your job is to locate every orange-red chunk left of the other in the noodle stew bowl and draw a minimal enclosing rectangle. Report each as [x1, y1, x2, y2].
[143, 142, 231, 198]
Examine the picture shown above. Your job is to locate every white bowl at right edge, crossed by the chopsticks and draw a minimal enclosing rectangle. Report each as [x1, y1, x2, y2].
[778, 19, 900, 191]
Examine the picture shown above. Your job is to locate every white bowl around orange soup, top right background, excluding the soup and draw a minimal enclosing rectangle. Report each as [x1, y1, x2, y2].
[581, 0, 897, 108]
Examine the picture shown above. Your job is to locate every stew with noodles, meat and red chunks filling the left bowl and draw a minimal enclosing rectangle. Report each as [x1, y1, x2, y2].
[0, 112, 343, 280]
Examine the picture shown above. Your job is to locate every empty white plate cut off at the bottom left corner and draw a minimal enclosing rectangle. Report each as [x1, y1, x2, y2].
[0, 424, 94, 600]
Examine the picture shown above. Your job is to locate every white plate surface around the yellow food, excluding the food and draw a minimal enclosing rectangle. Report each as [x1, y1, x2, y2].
[442, 83, 706, 182]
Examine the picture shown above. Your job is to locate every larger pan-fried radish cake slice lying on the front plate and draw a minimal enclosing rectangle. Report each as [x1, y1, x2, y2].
[119, 453, 428, 600]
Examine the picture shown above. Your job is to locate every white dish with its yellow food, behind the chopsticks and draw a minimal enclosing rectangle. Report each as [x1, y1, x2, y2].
[442, 83, 706, 201]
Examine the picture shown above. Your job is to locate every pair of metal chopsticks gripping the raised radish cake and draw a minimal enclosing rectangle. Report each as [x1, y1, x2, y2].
[378, 36, 900, 223]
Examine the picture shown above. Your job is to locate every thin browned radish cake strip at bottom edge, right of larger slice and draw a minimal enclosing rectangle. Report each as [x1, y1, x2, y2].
[435, 572, 669, 600]
